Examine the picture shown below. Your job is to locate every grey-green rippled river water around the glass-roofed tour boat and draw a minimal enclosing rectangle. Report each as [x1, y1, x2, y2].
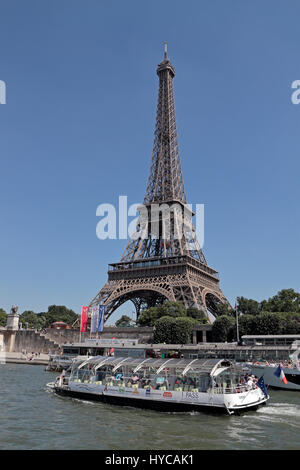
[0, 364, 300, 450]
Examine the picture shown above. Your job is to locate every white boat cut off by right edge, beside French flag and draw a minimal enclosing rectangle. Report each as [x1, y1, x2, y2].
[247, 349, 300, 390]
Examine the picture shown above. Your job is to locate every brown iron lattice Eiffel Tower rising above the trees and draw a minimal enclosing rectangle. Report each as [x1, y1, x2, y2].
[89, 44, 228, 320]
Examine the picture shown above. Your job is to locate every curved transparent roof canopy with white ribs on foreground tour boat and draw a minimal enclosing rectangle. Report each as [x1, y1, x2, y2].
[72, 356, 233, 375]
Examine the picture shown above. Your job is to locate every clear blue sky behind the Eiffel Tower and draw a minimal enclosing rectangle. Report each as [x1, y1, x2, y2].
[0, 0, 300, 322]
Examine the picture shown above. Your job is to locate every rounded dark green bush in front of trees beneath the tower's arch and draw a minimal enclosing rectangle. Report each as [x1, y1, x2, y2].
[153, 316, 197, 344]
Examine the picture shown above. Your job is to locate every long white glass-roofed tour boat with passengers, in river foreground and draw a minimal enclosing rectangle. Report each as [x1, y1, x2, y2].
[49, 356, 269, 414]
